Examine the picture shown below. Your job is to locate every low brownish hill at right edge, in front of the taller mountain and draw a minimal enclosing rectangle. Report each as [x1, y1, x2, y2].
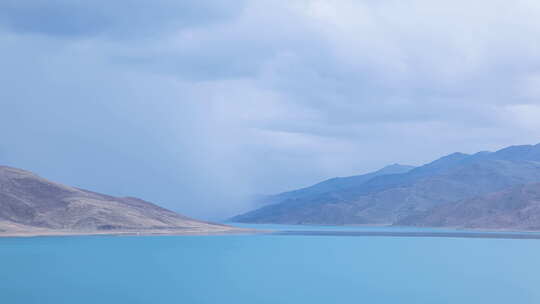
[396, 183, 540, 230]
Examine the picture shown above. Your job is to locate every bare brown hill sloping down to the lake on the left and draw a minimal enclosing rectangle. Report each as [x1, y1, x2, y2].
[0, 166, 242, 236]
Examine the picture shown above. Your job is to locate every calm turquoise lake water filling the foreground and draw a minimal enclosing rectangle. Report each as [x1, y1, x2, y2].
[0, 226, 540, 304]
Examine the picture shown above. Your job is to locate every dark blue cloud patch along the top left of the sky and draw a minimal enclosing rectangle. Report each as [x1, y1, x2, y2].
[0, 0, 243, 39]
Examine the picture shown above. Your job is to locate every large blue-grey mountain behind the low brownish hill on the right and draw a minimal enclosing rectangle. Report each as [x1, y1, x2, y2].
[233, 144, 540, 224]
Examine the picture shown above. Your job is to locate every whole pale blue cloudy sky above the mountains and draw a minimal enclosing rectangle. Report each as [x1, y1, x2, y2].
[0, 0, 540, 219]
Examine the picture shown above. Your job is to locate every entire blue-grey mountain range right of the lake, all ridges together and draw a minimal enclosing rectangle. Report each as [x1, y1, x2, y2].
[232, 144, 540, 229]
